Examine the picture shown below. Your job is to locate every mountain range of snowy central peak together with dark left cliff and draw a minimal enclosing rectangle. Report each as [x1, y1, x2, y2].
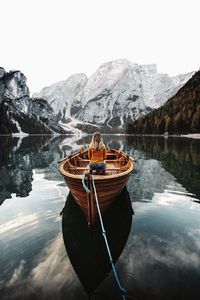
[0, 59, 194, 134]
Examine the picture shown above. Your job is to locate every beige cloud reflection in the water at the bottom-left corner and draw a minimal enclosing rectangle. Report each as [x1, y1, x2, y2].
[0, 233, 81, 300]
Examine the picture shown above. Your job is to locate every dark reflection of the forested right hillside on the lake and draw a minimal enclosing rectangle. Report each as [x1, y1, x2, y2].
[126, 136, 200, 198]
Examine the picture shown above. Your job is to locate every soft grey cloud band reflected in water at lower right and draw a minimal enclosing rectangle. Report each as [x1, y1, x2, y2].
[121, 230, 200, 281]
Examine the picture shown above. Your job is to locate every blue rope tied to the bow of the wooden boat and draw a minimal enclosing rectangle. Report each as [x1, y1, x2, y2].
[82, 175, 126, 300]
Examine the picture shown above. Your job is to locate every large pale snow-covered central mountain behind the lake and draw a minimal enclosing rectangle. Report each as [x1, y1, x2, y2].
[33, 60, 193, 132]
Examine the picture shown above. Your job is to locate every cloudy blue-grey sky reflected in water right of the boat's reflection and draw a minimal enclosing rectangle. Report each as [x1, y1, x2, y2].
[119, 198, 200, 300]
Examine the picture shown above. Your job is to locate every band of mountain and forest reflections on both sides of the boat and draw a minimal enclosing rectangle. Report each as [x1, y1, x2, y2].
[0, 136, 200, 204]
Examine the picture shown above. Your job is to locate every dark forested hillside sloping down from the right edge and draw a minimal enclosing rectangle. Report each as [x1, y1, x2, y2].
[126, 71, 200, 134]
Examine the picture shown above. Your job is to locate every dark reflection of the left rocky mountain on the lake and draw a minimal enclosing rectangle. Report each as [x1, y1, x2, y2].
[0, 135, 69, 204]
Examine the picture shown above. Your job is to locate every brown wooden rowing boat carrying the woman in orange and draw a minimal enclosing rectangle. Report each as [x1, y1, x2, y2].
[60, 149, 134, 225]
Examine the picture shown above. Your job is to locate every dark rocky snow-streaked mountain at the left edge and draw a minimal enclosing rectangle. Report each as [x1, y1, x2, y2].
[0, 67, 65, 135]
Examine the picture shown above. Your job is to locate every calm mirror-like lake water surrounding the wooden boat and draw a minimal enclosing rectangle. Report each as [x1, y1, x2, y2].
[0, 136, 200, 300]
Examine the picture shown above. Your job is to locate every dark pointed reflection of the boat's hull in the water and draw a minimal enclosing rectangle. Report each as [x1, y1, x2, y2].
[62, 187, 133, 295]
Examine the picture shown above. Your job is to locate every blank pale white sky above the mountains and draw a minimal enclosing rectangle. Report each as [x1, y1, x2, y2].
[0, 0, 200, 94]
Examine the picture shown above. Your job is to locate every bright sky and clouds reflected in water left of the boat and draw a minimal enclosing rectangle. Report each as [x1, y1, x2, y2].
[0, 171, 72, 300]
